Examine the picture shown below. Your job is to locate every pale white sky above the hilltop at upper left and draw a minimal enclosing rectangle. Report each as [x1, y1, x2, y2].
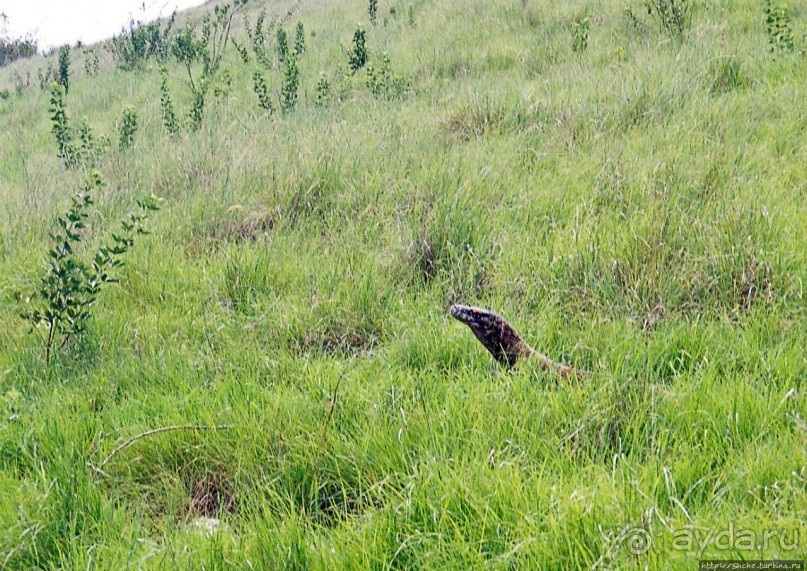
[0, 0, 204, 50]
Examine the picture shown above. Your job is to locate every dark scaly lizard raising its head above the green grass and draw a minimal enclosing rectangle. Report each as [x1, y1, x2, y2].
[451, 305, 586, 379]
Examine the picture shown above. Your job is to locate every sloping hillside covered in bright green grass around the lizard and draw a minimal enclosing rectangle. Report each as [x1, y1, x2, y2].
[0, 0, 807, 569]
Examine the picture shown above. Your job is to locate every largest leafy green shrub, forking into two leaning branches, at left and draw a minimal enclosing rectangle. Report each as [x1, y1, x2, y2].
[20, 172, 157, 363]
